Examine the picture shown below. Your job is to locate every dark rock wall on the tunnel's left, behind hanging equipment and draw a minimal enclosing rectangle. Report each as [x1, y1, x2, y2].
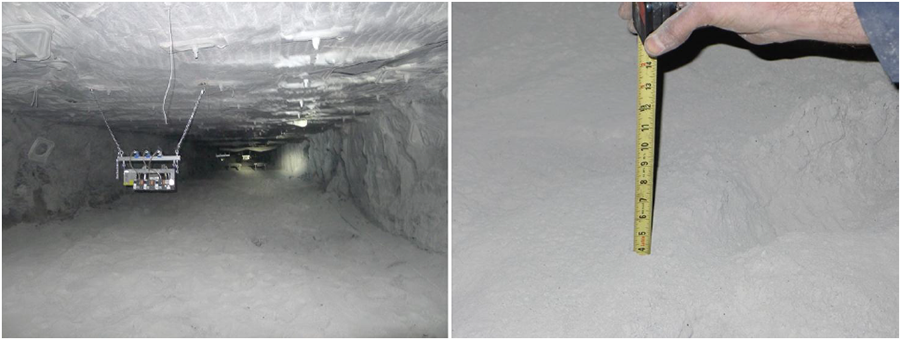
[3, 114, 204, 229]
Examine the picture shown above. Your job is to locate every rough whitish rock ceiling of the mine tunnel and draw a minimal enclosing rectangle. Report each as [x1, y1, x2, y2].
[2, 3, 447, 144]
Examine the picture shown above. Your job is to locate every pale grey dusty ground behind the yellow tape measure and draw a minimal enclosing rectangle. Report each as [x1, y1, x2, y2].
[452, 4, 898, 337]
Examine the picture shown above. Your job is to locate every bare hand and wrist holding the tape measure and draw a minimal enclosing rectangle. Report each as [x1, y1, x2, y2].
[619, 2, 869, 57]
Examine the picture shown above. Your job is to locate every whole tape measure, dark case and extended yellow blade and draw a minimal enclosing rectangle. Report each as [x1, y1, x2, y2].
[631, 2, 678, 255]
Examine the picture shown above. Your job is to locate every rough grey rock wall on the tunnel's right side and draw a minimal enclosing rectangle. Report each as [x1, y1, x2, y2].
[276, 89, 448, 253]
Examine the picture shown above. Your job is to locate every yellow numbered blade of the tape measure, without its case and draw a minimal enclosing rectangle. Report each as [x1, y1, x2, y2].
[634, 38, 656, 255]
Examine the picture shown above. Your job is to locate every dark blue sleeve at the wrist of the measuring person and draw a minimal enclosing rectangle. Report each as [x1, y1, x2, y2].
[854, 2, 898, 83]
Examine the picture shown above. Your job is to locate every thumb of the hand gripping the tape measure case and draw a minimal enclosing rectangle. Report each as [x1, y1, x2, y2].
[644, 3, 709, 57]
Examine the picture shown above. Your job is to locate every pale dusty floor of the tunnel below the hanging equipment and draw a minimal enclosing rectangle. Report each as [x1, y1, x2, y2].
[3, 170, 447, 337]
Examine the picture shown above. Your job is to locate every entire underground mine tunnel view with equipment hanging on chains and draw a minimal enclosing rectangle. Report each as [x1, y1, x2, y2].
[2, 3, 448, 337]
